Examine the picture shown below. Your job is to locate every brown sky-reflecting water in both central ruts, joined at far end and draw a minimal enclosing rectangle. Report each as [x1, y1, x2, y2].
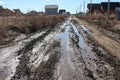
[56, 21, 97, 80]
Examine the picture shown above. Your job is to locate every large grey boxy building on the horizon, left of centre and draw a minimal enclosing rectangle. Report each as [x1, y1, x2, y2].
[45, 5, 58, 15]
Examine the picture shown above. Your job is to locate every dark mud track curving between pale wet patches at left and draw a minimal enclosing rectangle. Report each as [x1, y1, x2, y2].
[11, 30, 50, 80]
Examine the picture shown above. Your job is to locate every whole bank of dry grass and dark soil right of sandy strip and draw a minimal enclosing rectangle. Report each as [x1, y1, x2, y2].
[77, 15, 120, 43]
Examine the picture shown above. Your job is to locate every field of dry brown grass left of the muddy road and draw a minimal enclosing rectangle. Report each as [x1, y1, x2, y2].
[0, 15, 65, 45]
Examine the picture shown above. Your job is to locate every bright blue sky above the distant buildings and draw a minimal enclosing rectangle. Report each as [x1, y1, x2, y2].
[0, 0, 119, 13]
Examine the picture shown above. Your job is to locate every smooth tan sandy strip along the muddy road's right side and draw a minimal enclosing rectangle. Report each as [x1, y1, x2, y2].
[77, 19, 120, 58]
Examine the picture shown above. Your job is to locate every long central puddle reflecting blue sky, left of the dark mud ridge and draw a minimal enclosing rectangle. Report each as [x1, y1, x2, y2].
[55, 21, 84, 80]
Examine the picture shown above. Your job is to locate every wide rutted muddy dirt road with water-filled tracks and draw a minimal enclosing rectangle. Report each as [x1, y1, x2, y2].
[0, 18, 120, 80]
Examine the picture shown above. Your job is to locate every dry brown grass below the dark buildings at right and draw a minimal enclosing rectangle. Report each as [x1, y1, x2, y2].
[77, 15, 120, 33]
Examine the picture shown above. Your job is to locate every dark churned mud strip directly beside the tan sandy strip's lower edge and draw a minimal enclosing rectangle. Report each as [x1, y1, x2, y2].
[88, 37, 120, 80]
